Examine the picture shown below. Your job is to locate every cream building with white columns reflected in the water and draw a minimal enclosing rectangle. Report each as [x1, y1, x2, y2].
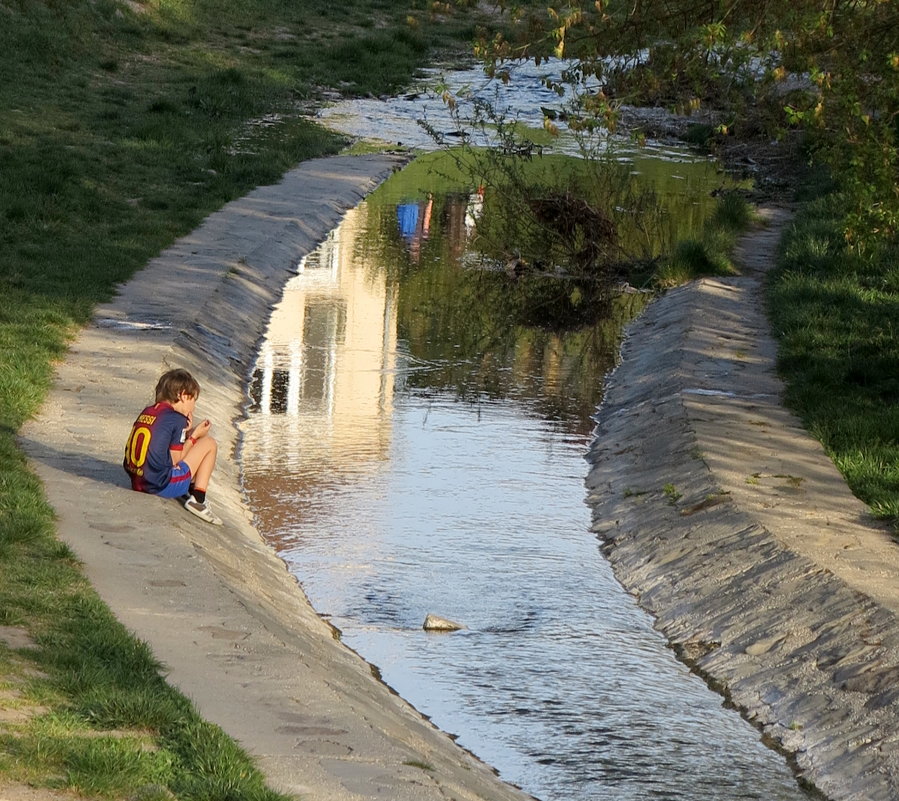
[242, 206, 396, 478]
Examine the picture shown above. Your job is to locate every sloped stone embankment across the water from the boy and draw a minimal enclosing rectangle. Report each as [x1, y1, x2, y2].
[588, 209, 899, 801]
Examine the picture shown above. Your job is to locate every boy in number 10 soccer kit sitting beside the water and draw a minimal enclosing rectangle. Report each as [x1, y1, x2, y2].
[123, 369, 222, 526]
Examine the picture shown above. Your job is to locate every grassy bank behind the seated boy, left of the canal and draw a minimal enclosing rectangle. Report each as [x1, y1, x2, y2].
[0, 0, 478, 801]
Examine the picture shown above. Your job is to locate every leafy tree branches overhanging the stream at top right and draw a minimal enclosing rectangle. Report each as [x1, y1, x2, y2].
[460, 0, 899, 246]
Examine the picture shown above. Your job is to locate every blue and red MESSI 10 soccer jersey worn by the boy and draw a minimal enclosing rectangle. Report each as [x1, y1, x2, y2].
[122, 401, 190, 494]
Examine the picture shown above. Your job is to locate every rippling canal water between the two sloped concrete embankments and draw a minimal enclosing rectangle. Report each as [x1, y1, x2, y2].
[241, 148, 805, 801]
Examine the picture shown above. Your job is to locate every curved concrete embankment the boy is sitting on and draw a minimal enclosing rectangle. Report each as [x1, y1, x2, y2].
[20, 156, 528, 801]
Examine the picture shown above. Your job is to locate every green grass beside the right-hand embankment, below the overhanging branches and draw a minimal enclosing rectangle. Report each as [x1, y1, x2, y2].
[768, 178, 899, 532]
